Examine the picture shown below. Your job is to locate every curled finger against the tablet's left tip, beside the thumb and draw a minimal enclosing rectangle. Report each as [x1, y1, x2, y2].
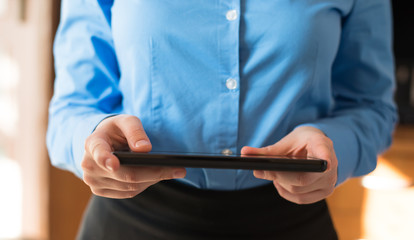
[85, 133, 119, 172]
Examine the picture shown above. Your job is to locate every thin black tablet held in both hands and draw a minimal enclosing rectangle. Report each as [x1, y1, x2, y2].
[113, 151, 327, 172]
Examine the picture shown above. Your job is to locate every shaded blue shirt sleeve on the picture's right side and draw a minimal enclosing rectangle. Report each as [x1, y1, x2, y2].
[300, 0, 397, 185]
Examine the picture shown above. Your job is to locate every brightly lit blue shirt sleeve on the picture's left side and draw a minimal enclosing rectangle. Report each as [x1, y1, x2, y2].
[46, 0, 122, 177]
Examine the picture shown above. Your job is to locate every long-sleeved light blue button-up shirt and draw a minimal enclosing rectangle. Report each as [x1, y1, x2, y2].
[47, 0, 396, 190]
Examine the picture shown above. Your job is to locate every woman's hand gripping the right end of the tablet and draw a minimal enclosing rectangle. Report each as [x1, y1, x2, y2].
[241, 126, 338, 204]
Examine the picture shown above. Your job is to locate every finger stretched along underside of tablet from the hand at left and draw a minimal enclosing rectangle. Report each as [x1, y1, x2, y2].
[111, 166, 187, 183]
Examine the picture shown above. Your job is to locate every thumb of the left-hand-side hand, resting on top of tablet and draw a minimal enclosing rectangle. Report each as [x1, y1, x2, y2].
[117, 116, 152, 152]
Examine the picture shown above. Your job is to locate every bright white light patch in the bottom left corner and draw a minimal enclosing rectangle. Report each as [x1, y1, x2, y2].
[0, 156, 22, 239]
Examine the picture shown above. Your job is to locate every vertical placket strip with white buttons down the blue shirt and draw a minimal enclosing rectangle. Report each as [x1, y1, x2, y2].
[210, 0, 240, 188]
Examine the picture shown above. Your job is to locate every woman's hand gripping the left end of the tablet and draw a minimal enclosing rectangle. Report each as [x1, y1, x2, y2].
[82, 115, 186, 199]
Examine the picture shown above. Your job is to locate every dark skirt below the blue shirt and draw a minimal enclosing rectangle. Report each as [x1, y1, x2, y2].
[78, 181, 338, 240]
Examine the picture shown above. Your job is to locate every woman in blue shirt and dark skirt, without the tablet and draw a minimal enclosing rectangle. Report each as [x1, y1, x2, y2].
[48, 0, 396, 239]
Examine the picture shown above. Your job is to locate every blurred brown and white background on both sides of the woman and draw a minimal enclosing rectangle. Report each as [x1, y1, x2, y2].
[0, 0, 414, 240]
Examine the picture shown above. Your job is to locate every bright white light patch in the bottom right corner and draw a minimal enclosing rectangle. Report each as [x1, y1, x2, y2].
[361, 159, 414, 240]
